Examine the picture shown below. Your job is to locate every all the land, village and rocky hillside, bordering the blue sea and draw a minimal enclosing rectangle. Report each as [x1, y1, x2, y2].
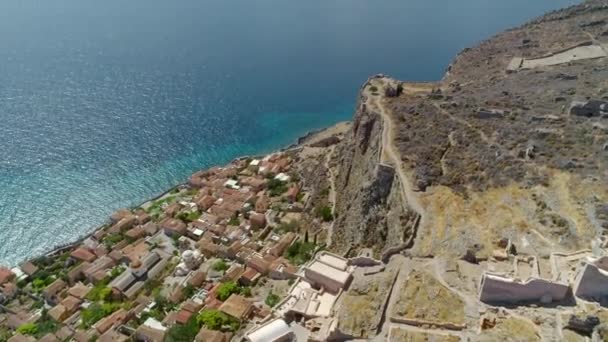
[0, 0, 608, 342]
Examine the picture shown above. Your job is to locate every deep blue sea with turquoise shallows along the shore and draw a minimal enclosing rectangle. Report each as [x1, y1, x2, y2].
[0, 0, 576, 264]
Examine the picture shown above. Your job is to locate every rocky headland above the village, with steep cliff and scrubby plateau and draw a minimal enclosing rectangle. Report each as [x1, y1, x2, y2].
[332, 1, 608, 257]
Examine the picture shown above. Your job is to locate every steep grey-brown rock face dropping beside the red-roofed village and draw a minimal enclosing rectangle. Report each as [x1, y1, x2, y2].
[331, 87, 415, 257]
